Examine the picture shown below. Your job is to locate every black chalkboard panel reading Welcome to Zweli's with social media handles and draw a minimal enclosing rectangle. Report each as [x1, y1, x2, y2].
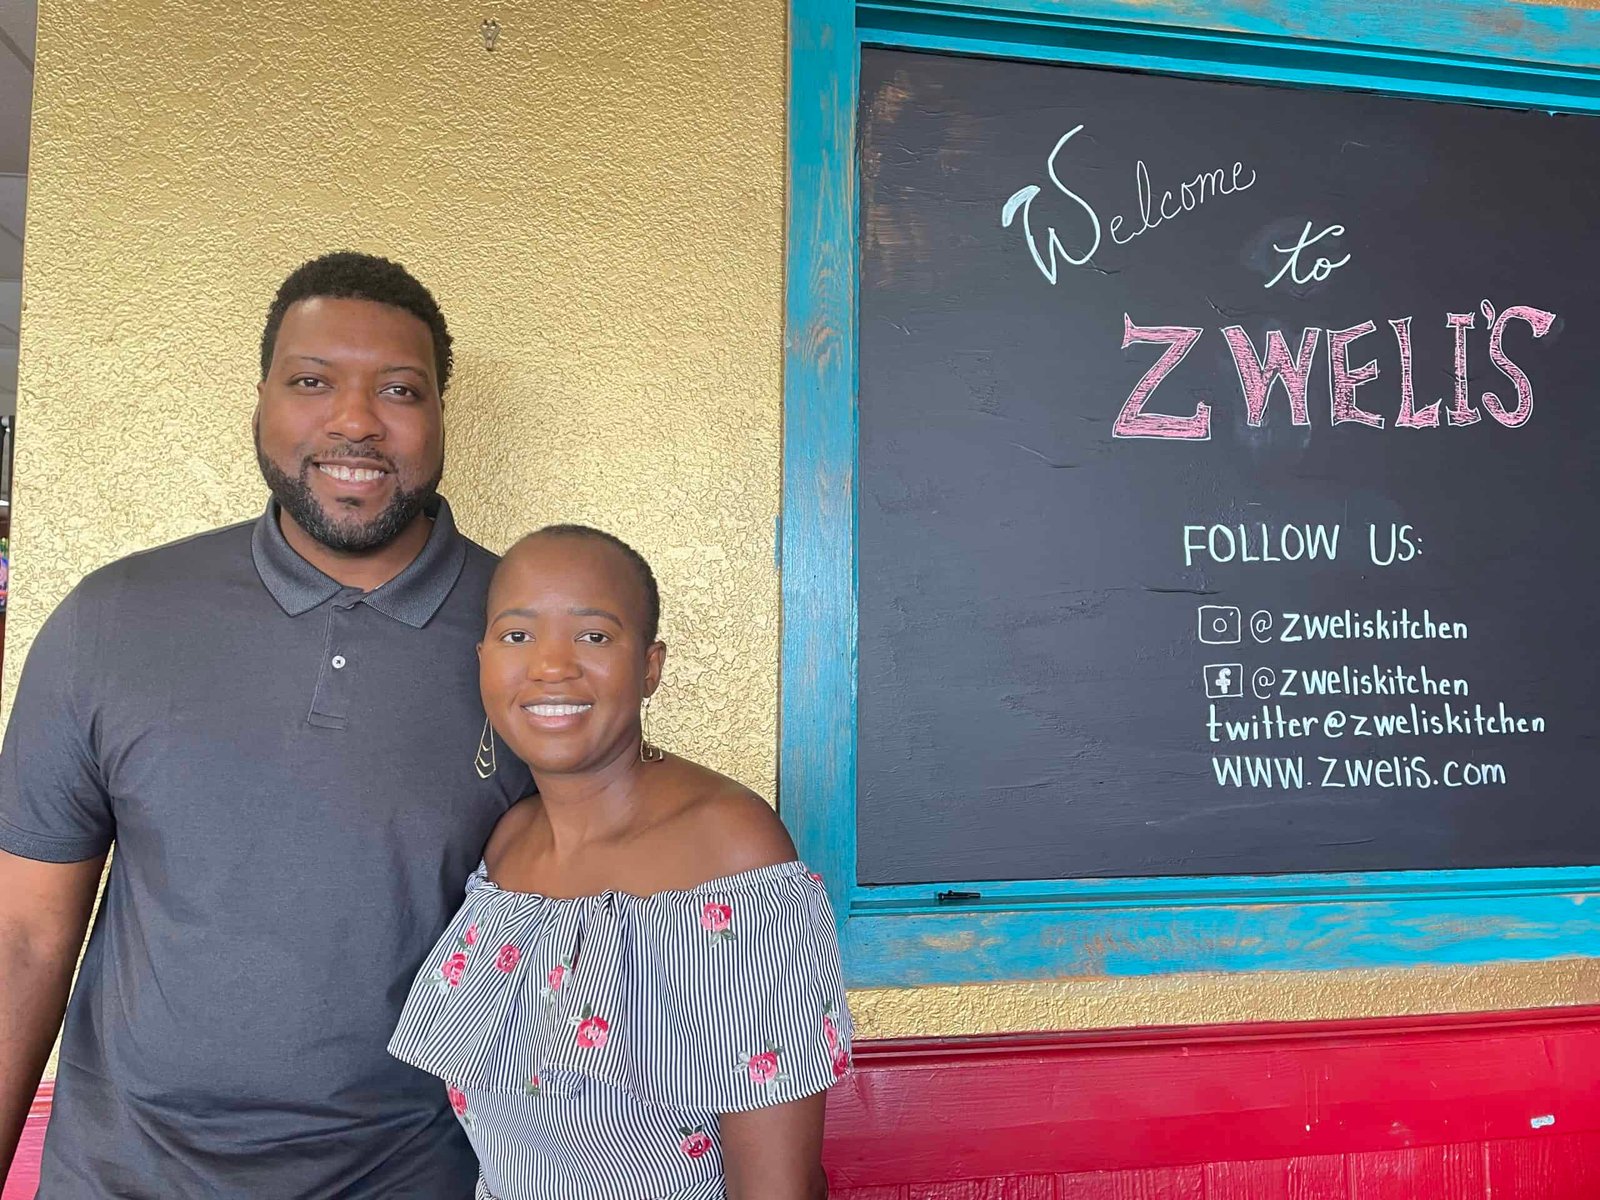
[856, 50, 1600, 883]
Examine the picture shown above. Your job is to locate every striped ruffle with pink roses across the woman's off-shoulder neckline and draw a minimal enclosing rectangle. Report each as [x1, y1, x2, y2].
[389, 861, 850, 1112]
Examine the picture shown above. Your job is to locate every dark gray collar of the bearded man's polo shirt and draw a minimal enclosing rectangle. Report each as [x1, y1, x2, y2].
[250, 496, 467, 629]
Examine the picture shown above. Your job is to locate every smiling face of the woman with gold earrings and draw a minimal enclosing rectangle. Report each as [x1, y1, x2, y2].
[478, 534, 667, 776]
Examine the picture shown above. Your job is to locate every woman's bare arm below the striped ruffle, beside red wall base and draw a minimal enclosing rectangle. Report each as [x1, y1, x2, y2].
[718, 1091, 827, 1200]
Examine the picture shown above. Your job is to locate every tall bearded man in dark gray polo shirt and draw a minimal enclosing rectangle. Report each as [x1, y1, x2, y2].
[0, 253, 530, 1200]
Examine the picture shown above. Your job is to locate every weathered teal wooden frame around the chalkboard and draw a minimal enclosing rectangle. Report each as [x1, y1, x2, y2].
[779, 0, 1600, 987]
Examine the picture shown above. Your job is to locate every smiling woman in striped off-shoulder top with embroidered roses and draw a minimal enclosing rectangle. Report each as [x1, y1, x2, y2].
[389, 525, 850, 1200]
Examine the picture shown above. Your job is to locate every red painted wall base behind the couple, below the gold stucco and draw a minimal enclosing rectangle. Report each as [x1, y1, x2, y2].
[9, 1008, 1600, 1200]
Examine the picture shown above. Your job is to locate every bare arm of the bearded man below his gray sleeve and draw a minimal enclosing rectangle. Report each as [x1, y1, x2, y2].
[0, 850, 106, 1179]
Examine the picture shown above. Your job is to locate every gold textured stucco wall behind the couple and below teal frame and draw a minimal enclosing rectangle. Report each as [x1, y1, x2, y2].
[9, 0, 1600, 1037]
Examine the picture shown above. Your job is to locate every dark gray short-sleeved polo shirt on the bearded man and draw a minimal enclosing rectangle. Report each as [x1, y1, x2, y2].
[0, 502, 530, 1200]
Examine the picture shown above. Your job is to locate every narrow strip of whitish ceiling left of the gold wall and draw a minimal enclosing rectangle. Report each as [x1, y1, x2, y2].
[0, 0, 38, 414]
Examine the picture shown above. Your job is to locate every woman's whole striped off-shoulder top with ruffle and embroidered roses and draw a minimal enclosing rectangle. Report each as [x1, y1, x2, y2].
[389, 862, 851, 1200]
